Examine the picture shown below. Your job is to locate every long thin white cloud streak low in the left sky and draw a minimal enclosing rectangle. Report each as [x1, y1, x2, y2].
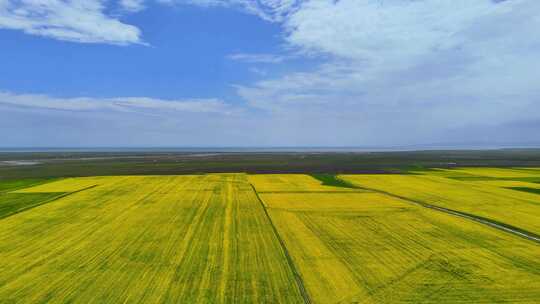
[0, 92, 235, 114]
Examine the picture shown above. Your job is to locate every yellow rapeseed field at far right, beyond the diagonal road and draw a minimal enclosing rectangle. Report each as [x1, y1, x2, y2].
[341, 174, 540, 234]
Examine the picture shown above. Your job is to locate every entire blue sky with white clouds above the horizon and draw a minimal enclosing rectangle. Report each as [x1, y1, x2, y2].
[0, 0, 540, 147]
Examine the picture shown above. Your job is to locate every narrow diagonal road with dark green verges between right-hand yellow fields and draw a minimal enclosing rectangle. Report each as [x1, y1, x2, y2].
[336, 177, 540, 243]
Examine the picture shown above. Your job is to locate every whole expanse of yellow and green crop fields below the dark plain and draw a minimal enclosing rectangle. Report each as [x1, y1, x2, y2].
[0, 168, 540, 303]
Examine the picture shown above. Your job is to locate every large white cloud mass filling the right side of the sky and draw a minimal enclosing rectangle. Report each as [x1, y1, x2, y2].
[237, 0, 540, 144]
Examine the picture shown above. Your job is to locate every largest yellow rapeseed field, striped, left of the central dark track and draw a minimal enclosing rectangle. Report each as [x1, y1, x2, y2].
[0, 174, 302, 303]
